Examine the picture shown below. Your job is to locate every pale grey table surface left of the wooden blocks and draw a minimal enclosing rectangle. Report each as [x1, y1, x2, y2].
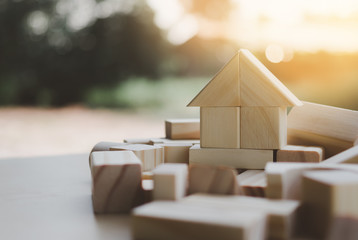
[0, 154, 131, 240]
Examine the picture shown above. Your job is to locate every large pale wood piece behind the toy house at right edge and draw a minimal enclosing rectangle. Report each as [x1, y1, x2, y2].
[287, 102, 358, 157]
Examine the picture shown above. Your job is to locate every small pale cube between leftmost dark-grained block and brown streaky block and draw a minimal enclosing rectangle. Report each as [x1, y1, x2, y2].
[153, 163, 188, 200]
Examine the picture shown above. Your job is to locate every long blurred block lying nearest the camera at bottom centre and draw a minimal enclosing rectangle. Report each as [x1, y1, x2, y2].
[131, 201, 266, 240]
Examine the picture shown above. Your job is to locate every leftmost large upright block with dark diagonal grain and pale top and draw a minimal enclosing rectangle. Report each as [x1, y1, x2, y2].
[91, 151, 142, 213]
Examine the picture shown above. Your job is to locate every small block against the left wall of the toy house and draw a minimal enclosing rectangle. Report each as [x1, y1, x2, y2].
[165, 119, 200, 139]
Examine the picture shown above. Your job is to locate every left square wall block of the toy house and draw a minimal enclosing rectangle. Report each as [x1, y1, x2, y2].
[200, 107, 240, 148]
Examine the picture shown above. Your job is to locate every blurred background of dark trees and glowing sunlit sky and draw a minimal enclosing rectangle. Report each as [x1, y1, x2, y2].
[0, 0, 358, 112]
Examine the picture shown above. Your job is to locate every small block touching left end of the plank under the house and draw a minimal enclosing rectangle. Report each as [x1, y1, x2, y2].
[154, 143, 193, 164]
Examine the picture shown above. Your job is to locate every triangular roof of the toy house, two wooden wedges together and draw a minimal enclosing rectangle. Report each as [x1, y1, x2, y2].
[188, 49, 302, 107]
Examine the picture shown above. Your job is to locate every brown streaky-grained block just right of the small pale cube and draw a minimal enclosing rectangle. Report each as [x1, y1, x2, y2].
[189, 165, 239, 195]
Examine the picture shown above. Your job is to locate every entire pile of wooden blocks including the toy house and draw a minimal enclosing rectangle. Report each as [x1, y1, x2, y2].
[90, 50, 358, 240]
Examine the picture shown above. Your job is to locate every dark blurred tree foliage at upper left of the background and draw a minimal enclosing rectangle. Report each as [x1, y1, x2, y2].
[0, 0, 168, 106]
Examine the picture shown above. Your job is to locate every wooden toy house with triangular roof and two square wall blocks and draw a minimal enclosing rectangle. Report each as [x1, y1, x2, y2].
[188, 49, 302, 150]
